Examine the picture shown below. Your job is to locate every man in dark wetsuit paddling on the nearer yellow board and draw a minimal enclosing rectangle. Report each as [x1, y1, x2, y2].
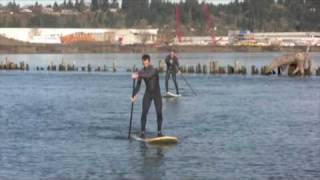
[131, 54, 162, 138]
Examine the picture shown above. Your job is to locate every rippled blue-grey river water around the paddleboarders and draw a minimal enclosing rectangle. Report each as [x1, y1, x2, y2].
[0, 53, 320, 180]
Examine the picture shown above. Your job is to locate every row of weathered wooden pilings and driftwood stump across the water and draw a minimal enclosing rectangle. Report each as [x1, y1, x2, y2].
[0, 58, 320, 76]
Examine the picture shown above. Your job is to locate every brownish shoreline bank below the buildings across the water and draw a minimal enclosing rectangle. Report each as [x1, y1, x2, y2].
[0, 43, 320, 54]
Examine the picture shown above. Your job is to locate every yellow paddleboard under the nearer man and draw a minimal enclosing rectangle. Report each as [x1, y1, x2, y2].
[132, 136, 178, 145]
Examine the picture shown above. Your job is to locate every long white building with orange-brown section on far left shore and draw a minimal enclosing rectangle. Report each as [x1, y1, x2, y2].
[0, 28, 158, 45]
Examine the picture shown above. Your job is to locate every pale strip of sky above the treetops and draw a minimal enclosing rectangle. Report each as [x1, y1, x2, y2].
[0, 0, 232, 5]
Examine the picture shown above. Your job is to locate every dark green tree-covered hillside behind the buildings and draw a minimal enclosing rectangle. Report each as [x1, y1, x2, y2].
[0, 0, 320, 35]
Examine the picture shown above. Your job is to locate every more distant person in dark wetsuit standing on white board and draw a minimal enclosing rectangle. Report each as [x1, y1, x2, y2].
[166, 51, 180, 94]
